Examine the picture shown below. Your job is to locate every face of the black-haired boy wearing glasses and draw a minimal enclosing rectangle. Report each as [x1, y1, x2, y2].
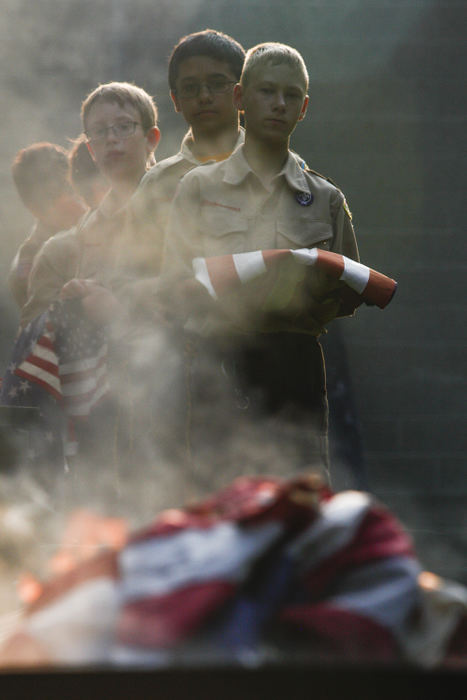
[170, 56, 238, 138]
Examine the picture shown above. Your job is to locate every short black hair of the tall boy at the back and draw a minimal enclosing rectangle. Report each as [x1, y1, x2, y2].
[169, 29, 245, 91]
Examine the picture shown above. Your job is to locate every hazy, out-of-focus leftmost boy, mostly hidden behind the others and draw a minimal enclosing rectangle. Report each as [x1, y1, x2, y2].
[8, 141, 86, 307]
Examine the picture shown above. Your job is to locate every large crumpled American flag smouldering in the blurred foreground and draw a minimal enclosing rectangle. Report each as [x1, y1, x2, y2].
[4, 476, 467, 666]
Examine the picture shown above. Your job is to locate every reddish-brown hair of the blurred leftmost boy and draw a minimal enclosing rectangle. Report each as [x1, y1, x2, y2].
[11, 141, 71, 209]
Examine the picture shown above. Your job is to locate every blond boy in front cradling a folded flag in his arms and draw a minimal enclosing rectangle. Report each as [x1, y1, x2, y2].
[164, 43, 358, 482]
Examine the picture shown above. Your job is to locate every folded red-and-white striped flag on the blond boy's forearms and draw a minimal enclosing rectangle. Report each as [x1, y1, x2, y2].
[193, 248, 397, 312]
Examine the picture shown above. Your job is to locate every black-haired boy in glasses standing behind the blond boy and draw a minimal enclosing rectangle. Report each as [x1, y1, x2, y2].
[130, 29, 245, 274]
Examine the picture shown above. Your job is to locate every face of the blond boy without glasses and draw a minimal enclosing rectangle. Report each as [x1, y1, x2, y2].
[234, 63, 308, 143]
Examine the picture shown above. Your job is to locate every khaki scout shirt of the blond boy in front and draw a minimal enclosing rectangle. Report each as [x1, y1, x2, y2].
[163, 147, 359, 335]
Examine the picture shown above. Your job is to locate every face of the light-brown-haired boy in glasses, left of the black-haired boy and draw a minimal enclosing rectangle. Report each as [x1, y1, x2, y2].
[86, 99, 160, 183]
